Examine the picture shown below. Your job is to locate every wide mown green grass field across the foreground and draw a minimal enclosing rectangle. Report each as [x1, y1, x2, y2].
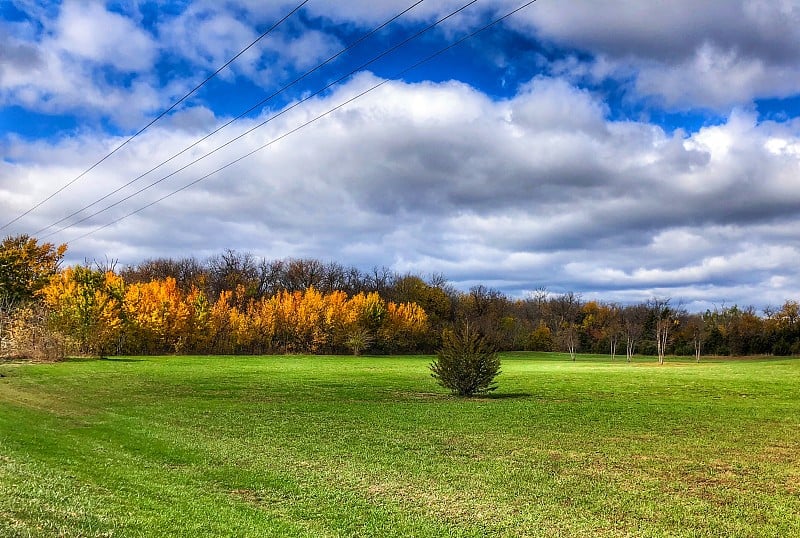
[0, 354, 800, 537]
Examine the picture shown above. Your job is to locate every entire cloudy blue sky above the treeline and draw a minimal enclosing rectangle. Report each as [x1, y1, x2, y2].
[0, 0, 800, 311]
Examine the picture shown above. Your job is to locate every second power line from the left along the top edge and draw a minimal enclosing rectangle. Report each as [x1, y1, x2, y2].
[33, 0, 425, 237]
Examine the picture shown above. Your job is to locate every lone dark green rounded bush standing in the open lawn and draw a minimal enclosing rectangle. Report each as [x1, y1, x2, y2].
[430, 325, 500, 396]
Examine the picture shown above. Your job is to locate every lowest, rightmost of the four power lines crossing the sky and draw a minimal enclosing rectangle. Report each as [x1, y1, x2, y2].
[67, 0, 537, 243]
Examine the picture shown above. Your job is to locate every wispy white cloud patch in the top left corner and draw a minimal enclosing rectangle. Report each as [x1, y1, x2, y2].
[0, 2, 161, 126]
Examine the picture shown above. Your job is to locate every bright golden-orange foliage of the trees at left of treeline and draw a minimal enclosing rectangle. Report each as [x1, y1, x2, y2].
[41, 266, 427, 354]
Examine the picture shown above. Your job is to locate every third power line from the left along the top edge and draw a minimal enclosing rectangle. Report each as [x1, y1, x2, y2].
[42, 0, 478, 239]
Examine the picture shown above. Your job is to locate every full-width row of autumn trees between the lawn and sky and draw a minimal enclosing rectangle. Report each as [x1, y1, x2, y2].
[0, 236, 800, 361]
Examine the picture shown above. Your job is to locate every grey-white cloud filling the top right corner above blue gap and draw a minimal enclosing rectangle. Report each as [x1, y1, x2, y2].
[498, 0, 800, 111]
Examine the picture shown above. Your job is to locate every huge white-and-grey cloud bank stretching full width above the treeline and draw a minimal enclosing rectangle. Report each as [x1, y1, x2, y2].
[0, 74, 800, 307]
